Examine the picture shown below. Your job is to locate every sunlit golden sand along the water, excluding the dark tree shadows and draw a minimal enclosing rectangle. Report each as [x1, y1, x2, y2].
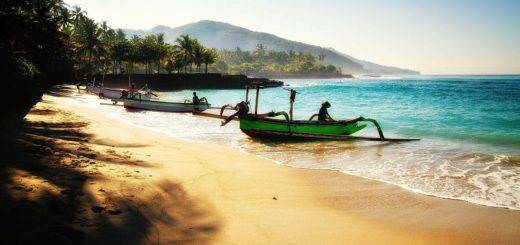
[8, 86, 520, 244]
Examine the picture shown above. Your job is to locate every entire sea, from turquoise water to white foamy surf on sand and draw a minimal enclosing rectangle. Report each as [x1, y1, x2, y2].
[75, 76, 520, 209]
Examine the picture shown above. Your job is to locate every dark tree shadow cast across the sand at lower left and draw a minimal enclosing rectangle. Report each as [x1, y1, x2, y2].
[0, 97, 220, 244]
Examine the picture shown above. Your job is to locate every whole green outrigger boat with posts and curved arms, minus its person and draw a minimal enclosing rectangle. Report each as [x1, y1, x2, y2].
[220, 85, 419, 141]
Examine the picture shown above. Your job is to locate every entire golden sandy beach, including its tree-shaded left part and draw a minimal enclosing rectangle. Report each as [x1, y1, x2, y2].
[2, 88, 520, 244]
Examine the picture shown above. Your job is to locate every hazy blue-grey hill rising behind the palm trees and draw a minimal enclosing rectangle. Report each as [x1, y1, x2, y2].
[124, 20, 419, 75]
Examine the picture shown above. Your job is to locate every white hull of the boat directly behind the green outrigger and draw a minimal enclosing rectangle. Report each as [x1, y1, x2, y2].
[120, 98, 211, 112]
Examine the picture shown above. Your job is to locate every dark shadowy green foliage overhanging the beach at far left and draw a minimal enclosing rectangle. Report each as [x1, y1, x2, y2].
[0, 0, 73, 121]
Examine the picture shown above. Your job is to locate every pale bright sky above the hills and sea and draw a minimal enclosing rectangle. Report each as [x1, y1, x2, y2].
[65, 0, 520, 74]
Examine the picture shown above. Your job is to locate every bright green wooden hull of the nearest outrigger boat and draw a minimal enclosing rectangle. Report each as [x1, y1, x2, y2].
[240, 117, 366, 139]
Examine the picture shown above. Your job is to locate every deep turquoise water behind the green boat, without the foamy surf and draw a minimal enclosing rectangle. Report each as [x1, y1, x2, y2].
[168, 76, 520, 154]
